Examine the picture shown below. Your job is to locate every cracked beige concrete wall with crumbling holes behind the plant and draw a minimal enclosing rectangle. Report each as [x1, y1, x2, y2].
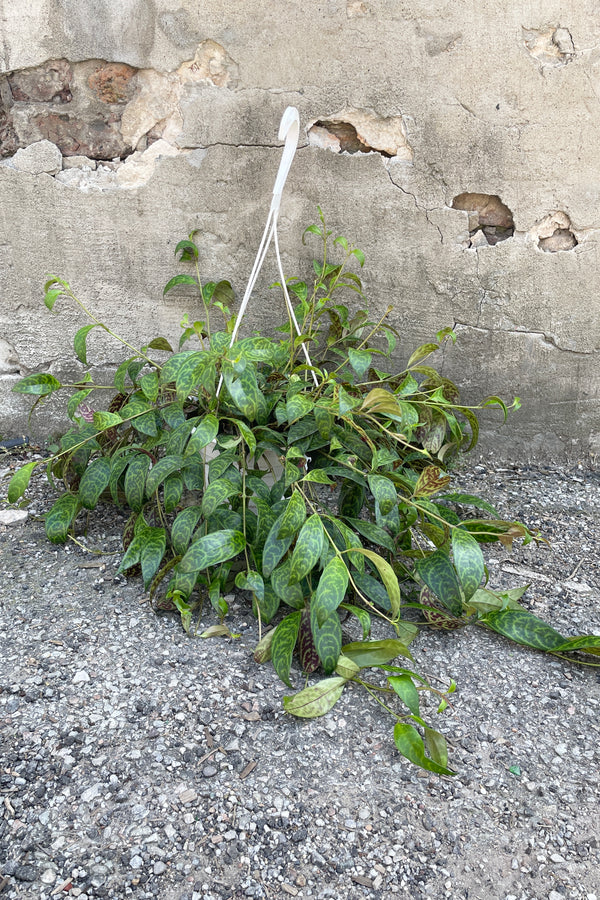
[0, 0, 600, 460]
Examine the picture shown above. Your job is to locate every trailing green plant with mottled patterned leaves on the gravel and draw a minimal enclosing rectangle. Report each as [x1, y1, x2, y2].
[8, 210, 600, 774]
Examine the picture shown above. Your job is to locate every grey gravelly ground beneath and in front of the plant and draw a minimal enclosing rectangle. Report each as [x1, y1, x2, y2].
[0, 452, 600, 900]
